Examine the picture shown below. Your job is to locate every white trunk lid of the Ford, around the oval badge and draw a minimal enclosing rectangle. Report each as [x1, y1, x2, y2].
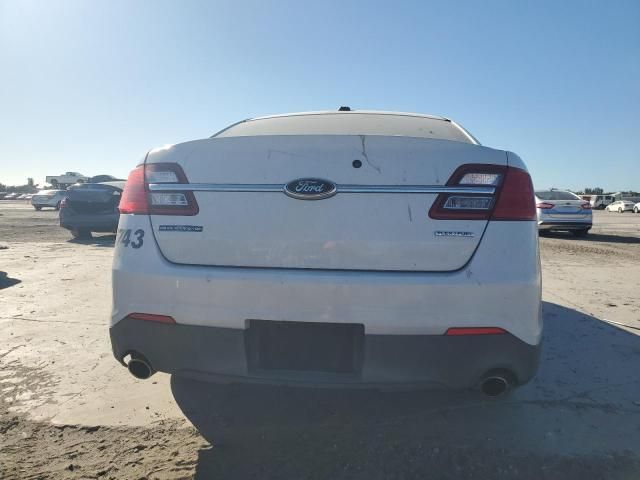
[147, 135, 507, 271]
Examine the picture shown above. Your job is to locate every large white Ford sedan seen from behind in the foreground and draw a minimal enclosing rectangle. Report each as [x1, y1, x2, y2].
[110, 108, 542, 395]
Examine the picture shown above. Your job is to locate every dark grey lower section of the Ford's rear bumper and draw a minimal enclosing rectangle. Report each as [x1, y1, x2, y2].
[110, 318, 540, 389]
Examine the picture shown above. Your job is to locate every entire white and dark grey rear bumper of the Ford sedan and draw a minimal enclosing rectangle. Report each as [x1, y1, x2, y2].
[110, 215, 542, 388]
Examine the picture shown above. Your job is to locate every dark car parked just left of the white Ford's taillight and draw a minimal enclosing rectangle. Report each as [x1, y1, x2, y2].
[60, 181, 125, 238]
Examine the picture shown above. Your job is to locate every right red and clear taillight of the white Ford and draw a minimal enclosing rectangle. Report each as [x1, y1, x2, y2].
[429, 164, 536, 220]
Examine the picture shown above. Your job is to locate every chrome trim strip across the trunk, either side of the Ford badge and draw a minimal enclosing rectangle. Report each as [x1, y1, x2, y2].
[149, 183, 496, 195]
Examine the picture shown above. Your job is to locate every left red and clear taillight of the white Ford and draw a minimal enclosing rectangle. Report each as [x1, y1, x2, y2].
[118, 163, 199, 216]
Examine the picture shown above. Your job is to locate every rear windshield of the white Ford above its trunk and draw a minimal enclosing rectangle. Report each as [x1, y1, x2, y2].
[215, 113, 476, 143]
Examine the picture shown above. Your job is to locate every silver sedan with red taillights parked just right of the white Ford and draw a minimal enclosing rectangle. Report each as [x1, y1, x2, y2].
[536, 190, 593, 237]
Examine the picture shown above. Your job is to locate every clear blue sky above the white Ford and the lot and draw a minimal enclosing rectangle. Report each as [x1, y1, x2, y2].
[0, 0, 640, 190]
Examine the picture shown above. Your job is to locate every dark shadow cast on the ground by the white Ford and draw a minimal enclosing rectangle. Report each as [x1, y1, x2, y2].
[171, 302, 640, 479]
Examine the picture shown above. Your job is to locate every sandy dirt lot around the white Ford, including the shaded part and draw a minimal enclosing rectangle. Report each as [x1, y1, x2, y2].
[0, 201, 640, 480]
